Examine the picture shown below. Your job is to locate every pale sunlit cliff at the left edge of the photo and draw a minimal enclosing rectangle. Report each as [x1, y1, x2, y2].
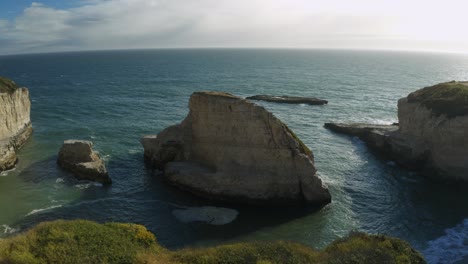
[0, 77, 32, 172]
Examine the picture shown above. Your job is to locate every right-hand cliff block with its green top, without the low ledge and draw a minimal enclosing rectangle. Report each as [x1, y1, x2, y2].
[398, 82, 468, 180]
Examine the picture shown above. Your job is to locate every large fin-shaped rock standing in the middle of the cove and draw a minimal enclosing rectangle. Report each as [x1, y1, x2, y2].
[142, 92, 331, 206]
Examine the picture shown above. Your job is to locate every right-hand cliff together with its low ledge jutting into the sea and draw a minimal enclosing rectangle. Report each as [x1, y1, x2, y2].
[325, 81, 468, 181]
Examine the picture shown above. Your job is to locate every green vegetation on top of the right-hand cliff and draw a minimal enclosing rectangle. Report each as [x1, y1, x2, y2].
[408, 81, 468, 118]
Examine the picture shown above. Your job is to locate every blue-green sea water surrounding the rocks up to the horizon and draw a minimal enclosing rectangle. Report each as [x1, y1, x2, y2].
[0, 49, 468, 263]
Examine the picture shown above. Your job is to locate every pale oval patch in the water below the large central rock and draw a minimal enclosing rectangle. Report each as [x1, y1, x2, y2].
[172, 206, 239, 225]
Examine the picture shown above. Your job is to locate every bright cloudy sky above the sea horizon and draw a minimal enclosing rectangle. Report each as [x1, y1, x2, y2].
[0, 0, 468, 55]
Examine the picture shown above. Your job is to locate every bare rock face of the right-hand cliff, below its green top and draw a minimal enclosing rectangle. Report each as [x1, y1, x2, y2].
[398, 98, 468, 180]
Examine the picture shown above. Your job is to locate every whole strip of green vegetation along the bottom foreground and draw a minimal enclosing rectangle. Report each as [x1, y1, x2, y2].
[0, 220, 425, 264]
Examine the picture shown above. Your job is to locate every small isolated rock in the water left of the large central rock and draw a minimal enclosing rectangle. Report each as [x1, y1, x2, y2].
[57, 140, 112, 184]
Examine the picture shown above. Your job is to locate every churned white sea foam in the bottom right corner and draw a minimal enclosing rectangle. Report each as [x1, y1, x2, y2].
[423, 219, 468, 264]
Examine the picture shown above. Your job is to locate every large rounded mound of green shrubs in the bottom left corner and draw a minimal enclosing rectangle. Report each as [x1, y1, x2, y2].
[0, 220, 162, 264]
